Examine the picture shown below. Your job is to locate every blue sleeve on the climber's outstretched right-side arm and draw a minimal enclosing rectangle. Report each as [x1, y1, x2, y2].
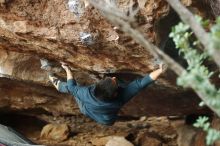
[120, 74, 154, 104]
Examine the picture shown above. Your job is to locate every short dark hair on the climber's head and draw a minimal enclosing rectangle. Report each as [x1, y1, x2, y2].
[95, 77, 118, 100]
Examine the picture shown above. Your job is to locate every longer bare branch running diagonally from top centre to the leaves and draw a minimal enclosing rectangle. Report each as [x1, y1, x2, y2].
[90, 0, 185, 75]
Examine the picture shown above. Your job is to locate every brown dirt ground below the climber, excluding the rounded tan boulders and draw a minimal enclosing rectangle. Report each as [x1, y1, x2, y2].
[0, 116, 180, 146]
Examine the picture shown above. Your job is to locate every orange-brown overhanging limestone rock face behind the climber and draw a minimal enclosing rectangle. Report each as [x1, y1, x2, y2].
[0, 0, 217, 123]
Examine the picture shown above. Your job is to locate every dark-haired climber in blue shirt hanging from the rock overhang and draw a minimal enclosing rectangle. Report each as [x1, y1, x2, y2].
[49, 63, 165, 125]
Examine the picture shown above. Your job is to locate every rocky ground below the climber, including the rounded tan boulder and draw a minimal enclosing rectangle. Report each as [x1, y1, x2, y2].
[0, 115, 208, 146]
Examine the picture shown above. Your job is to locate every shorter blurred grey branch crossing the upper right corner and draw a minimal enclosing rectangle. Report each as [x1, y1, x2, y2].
[166, 0, 220, 67]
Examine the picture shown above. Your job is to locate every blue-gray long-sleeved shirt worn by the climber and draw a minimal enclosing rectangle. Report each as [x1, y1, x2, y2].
[67, 75, 153, 125]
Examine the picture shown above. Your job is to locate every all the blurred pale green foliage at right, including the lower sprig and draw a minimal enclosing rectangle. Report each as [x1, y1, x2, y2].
[170, 21, 220, 145]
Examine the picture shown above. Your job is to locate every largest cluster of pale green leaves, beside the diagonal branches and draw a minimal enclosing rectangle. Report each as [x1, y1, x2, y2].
[170, 20, 220, 116]
